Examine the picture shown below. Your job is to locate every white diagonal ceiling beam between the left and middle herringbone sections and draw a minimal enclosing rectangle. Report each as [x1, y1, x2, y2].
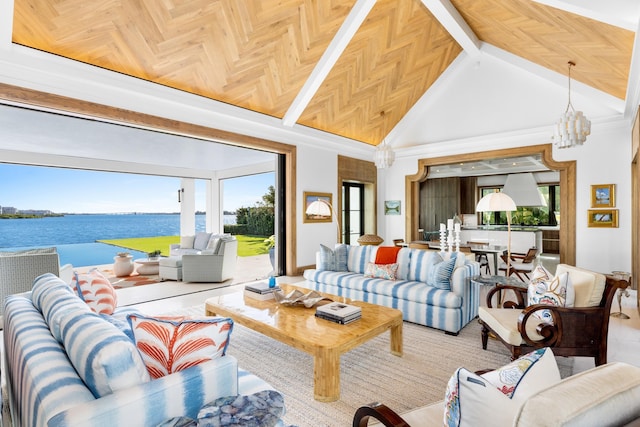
[282, 0, 376, 127]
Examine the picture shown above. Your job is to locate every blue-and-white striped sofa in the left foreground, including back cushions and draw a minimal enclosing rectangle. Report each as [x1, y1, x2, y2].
[4, 273, 282, 426]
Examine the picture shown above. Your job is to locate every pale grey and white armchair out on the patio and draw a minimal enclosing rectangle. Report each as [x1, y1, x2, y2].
[182, 239, 238, 283]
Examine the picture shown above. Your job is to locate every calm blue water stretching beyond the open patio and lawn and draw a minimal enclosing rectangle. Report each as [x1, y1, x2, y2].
[0, 214, 235, 267]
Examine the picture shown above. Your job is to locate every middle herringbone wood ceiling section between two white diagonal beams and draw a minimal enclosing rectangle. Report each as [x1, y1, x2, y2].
[299, 0, 462, 145]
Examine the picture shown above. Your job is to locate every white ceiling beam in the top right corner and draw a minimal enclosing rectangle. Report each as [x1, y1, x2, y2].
[532, 0, 638, 31]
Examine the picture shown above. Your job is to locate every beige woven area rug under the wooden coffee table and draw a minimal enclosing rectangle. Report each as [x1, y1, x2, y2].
[166, 305, 573, 427]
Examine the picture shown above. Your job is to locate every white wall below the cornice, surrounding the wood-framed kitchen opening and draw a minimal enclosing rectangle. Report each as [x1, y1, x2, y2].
[378, 120, 631, 273]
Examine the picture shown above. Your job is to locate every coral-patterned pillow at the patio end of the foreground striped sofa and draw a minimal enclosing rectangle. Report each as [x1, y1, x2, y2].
[70, 268, 118, 315]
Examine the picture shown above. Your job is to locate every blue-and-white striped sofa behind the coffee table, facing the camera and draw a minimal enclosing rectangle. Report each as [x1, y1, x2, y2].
[301, 245, 480, 335]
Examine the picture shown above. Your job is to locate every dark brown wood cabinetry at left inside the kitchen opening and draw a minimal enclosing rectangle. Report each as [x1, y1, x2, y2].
[418, 177, 478, 231]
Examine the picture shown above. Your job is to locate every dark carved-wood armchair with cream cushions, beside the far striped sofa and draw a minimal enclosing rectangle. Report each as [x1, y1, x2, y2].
[478, 264, 629, 366]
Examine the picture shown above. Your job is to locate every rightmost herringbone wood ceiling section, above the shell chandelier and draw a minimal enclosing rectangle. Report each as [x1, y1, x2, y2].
[451, 0, 635, 99]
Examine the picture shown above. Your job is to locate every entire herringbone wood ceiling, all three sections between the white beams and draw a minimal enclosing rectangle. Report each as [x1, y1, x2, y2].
[13, 0, 635, 145]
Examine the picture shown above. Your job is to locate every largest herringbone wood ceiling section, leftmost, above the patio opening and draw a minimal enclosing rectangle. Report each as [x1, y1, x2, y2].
[13, 0, 355, 117]
